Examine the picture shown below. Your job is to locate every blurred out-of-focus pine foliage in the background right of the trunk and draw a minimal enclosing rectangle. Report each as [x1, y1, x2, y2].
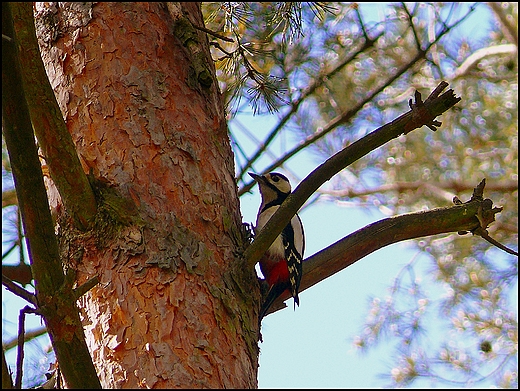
[203, 3, 518, 387]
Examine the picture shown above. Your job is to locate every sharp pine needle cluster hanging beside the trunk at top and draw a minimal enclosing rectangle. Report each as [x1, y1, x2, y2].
[203, 2, 332, 113]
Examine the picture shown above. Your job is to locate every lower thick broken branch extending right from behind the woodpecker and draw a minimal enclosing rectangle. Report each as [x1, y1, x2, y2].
[268, 188, 497, 313]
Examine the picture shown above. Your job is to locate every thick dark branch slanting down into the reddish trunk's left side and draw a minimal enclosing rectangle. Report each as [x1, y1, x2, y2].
[11, 2, 97, 230]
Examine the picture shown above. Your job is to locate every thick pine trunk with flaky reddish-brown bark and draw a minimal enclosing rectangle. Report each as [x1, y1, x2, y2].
[36, 3, 259, 388]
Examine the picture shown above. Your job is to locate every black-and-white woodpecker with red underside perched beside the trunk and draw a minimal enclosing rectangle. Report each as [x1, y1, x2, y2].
[249, 172, 305, 323]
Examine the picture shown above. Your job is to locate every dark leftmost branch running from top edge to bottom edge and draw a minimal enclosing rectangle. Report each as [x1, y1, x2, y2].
[2, 2, 101, 388]
